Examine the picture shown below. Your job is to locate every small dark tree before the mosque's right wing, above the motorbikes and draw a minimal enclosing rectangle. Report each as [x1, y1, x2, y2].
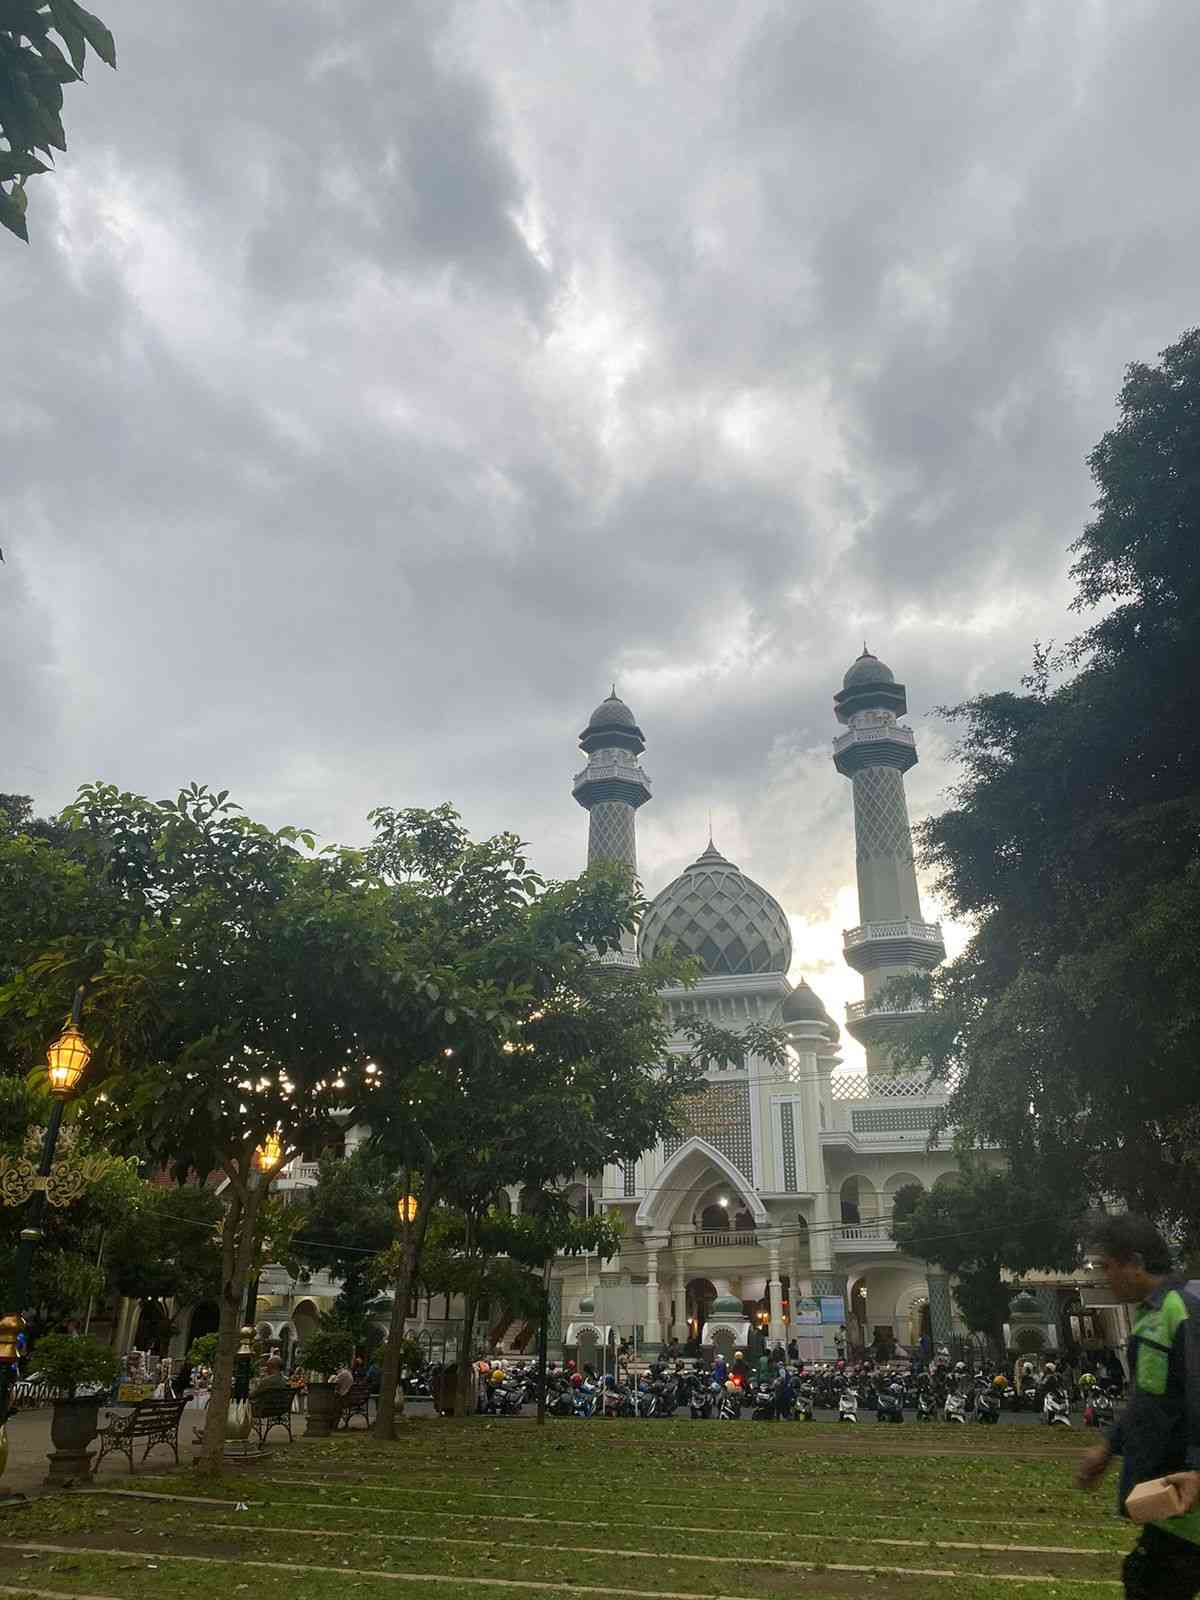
[891, 1171, 1080, 1358]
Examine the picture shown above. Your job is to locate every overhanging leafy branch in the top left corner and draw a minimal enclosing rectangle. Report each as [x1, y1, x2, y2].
[0, 0, 117, 243]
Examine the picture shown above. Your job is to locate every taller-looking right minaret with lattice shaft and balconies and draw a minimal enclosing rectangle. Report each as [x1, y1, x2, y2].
[834, 645, 946, 1075]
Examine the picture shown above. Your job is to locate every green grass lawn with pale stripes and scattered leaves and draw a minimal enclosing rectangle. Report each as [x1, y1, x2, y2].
[0, 1419, 1133, 1600]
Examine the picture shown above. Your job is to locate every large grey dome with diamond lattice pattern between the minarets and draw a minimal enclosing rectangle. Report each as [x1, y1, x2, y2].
[638, 843, 792, 978]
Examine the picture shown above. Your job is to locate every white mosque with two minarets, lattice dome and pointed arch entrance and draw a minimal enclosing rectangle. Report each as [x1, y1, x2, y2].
[557, 648, 955, 1360]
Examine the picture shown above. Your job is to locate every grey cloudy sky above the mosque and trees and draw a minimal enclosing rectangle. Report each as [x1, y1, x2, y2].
[0, 0, 1200, 1061]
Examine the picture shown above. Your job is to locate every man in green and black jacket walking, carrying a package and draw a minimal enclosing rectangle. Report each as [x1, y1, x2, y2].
[1077, 1214, 1200, 1600]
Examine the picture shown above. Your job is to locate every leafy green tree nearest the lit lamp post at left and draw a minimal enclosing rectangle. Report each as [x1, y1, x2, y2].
[0, 784, 404, 1469]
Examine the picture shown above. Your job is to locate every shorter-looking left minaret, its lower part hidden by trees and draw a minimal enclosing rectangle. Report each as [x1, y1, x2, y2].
[573, 685, 650, 965]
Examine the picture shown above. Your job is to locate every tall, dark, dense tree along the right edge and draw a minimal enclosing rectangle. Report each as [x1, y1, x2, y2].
[902, 330, 1200, 1245]
